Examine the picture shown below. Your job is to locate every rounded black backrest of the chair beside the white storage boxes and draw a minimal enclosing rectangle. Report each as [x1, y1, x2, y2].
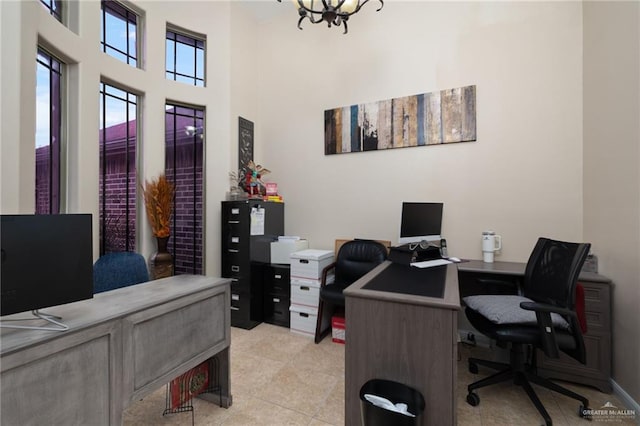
[335, 240, 387, 285]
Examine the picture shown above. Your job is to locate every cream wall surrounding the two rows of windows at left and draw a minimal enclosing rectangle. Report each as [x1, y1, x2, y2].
[0, 0, 231, 275]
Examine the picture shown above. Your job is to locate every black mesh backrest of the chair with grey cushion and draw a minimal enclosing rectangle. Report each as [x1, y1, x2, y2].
[523, 238, 591, 362]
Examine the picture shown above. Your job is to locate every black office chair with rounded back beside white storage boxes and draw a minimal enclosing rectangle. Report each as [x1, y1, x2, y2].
[315, 240, 387, 343]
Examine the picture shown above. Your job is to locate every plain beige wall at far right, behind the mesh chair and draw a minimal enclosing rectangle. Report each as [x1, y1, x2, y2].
[584, 2, 640, 401]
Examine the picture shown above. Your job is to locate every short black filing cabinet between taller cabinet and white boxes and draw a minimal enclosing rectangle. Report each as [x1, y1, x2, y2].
[264, 264, 291, 327]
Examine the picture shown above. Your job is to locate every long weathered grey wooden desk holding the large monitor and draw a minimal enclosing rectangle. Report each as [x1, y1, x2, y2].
[0, 275, 232, 425]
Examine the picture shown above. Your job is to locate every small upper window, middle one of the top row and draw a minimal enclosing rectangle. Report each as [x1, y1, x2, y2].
[100, 0, 138, 67]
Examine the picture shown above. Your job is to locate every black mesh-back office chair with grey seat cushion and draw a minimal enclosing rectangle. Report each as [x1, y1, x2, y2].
[463, 238, 590, 425]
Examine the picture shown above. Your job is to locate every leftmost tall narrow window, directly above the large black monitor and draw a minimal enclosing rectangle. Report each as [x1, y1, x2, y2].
[35, 49, 63, 214]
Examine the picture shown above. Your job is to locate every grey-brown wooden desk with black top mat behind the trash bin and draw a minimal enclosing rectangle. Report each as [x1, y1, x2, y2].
[344, 261, 460, 426]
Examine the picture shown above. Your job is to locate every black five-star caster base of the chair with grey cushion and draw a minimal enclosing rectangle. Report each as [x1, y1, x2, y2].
[467, 343, 589, 426]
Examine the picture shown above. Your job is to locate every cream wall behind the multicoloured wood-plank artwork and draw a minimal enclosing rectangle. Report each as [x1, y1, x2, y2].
[257, 1, 583, 261]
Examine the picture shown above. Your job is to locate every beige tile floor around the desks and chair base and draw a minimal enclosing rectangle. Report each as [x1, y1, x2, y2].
[123, 324, 640, 426]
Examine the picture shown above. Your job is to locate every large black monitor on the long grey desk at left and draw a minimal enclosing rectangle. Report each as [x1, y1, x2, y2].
[0, 214, 93, 326]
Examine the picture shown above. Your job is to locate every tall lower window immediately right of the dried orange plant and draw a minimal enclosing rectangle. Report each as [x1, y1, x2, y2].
[165, 104, 204, 274]
